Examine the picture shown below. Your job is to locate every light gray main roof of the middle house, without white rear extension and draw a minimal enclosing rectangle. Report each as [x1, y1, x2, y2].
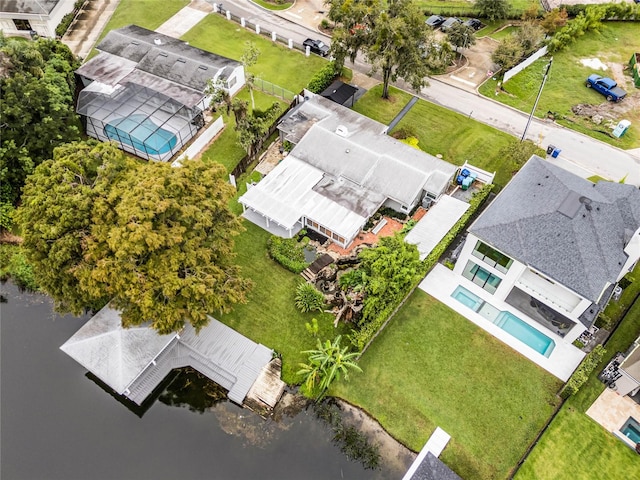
[279, 95, 457, 205]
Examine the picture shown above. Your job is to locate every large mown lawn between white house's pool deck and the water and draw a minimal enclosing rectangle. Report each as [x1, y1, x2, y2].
[330, 290, 561, 480]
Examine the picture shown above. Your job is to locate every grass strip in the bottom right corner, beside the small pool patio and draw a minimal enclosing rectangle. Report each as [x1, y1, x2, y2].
[515, 292, 640, 480]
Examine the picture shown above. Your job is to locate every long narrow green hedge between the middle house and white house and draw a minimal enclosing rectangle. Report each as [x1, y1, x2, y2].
[350, 185, 493, 353]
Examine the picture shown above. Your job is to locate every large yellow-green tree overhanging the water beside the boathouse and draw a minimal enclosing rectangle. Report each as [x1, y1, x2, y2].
[18, 141, 250, 333]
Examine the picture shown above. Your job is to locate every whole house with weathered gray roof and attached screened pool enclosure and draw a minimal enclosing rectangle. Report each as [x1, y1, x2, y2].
[76, 25, 245, 161]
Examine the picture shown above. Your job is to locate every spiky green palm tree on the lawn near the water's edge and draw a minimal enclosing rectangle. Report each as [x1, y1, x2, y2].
[298, 335, 362, 400]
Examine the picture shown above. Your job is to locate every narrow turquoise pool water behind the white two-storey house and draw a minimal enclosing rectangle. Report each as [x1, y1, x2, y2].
[451, 286, 556, 357]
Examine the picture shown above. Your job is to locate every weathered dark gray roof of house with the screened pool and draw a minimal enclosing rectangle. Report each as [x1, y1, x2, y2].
[97, 25, 241, 91]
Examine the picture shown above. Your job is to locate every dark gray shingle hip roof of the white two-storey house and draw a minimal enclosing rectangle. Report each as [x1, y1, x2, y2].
[469, 155, 640, 302]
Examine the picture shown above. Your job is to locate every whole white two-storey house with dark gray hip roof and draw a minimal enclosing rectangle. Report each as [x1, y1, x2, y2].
[454, 155, 640, 344]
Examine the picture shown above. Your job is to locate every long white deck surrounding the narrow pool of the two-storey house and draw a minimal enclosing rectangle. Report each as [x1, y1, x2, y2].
[420, 264, 585, 382]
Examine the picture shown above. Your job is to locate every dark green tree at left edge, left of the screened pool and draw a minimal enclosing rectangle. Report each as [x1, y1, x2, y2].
[0, 34, 80, 212]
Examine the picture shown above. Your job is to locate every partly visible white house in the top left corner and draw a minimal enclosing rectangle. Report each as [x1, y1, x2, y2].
[0, 0, 76, 38]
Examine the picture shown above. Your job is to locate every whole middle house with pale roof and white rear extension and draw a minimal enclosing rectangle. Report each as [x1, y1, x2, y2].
[239, 93, 457, 247]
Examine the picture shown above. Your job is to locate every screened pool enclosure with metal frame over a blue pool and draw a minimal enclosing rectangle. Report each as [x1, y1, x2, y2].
[77, 82, 203, 161]
